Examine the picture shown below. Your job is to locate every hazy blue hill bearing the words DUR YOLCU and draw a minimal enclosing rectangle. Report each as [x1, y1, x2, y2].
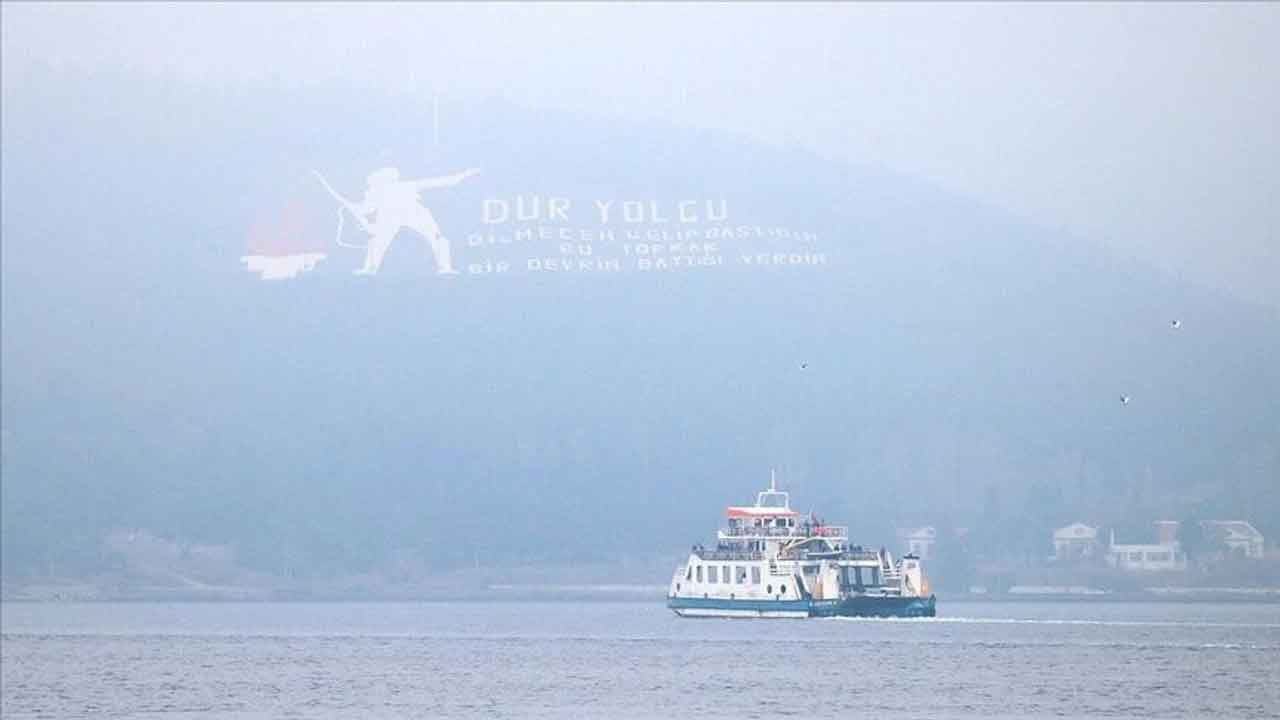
[0, 76, 1280, 574]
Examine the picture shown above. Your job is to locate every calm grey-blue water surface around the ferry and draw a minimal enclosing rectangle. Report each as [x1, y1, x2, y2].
[0, 602, 1280, 720]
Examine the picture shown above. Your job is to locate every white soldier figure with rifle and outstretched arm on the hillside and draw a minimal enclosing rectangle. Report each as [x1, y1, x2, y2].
[316, 168, 480, 275]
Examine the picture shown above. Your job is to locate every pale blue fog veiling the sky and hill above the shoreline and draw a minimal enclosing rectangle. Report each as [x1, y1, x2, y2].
[0, 4, 1280, 591]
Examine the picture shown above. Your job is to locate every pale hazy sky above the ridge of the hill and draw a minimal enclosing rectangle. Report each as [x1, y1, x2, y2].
[3, 3, 1280, 309]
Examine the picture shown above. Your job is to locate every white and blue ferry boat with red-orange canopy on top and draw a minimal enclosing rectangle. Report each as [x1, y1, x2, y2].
[667, 478, 937, 618]
